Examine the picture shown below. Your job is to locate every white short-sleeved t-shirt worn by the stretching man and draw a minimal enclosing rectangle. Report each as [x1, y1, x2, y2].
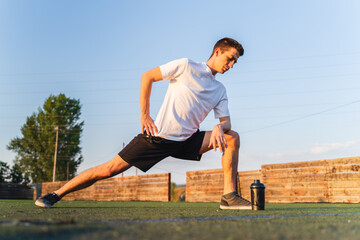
[155, 58, 230, 141]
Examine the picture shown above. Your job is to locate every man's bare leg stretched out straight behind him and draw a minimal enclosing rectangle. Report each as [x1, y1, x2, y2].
[55, 155, 131, 198]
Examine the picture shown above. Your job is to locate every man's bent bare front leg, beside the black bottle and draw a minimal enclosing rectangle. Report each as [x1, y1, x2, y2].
[200, 130, 240, 194]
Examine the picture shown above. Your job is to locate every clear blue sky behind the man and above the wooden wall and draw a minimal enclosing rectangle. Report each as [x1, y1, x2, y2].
[0, 0, 360, 183]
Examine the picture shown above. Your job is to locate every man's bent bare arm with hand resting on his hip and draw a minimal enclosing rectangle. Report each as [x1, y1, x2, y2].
[140, 67, 162, 135]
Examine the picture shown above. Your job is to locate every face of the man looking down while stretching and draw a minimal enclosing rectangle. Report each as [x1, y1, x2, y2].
[215, 48, 239, 74]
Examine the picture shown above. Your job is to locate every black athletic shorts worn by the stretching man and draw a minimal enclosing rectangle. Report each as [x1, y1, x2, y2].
[119, 130, 205, 172]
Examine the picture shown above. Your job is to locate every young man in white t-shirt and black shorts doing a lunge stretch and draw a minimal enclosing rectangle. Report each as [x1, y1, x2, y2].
[35, 38, 251, 209]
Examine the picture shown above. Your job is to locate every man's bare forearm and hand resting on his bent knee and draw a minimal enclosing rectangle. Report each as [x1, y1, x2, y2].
[208, 117, 231, 153]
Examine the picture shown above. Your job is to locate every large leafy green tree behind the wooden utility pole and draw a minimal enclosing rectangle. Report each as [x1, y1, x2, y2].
[7, 94, 84, 182]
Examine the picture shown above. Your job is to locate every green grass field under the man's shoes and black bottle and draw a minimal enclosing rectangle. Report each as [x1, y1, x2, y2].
[0, 200, 360, 240]
